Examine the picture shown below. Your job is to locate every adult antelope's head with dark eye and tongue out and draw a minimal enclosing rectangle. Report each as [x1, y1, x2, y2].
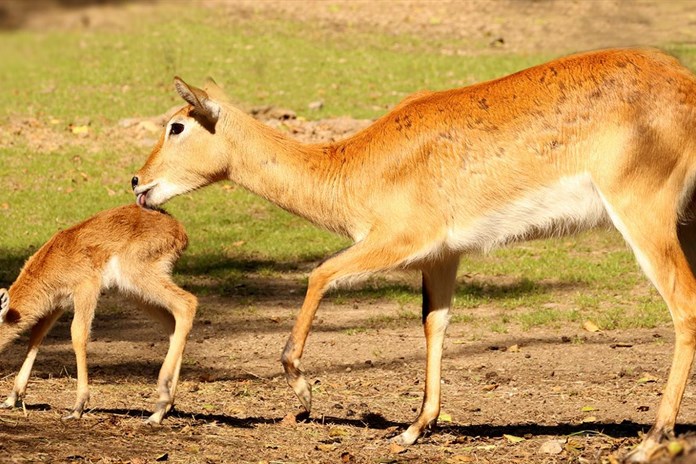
[131, 77, 227, 208]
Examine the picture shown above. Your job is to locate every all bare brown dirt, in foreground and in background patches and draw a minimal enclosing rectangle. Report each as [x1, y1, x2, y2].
[0, 0, 696, 464]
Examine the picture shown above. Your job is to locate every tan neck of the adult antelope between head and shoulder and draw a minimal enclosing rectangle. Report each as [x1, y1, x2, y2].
[226, 117, 355, 237]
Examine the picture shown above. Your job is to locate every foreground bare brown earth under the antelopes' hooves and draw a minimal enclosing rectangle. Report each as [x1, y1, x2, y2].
[0, 292, 696, 463]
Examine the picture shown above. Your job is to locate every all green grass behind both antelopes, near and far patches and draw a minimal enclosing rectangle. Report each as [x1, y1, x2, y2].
[0, 3, 696, 331]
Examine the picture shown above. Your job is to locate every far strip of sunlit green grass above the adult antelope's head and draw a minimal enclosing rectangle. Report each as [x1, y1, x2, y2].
[0, 9, 548, 124]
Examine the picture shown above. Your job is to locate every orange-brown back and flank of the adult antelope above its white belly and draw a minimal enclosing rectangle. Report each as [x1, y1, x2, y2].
[344, 49, 696, 227]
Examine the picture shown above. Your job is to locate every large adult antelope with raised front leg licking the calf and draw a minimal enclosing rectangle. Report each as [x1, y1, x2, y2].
[132, 49, 696, 461]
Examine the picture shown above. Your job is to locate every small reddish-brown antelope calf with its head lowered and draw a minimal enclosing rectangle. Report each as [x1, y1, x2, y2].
[0, 205, 197, 424]
